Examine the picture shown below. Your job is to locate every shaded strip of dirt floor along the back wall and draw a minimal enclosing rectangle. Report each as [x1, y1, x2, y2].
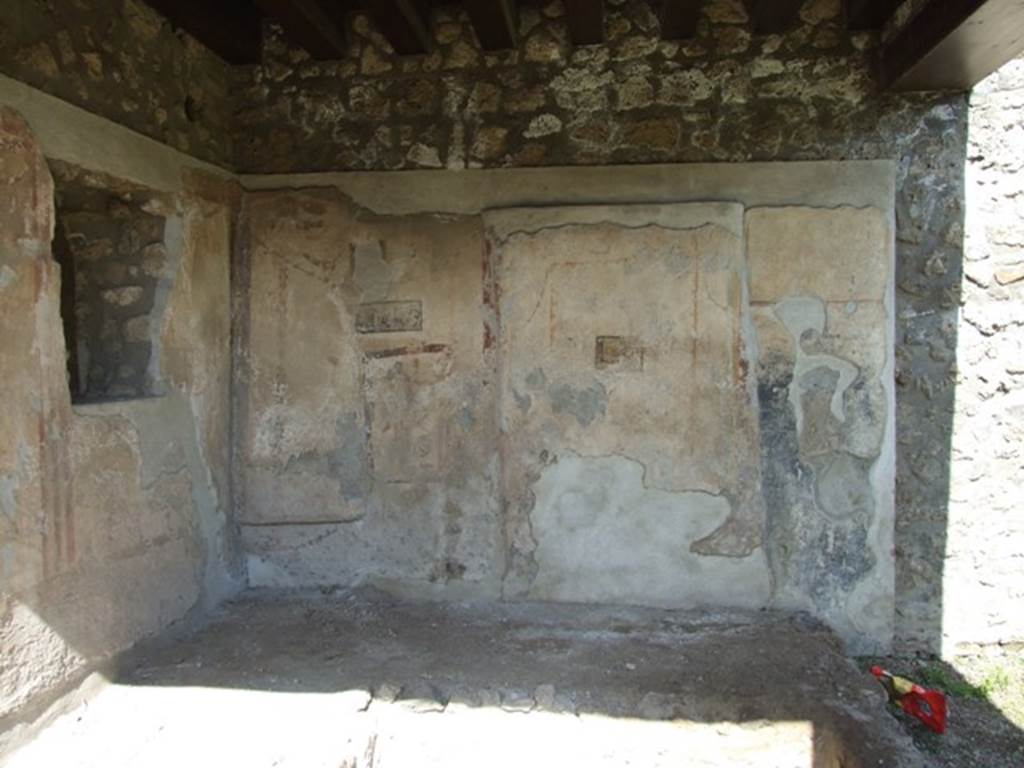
[97, 591, 937, 768]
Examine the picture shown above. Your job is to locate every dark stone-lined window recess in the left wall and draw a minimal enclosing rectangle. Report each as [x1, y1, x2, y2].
[53, 173, 167, 403]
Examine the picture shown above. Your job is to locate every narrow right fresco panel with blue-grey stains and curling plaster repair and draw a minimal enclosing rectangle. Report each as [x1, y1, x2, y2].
[746, 207, 895, 651]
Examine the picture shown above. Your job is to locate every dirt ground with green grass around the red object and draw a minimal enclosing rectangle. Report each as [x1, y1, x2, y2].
[861, 651, 1024, 768]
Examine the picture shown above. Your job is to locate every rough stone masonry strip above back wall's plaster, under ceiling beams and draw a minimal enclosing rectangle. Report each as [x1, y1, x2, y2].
[232, 0, 964, 173]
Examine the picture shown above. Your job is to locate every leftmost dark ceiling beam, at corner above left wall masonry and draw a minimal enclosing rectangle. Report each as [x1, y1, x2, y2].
[146, 0, 263, 65]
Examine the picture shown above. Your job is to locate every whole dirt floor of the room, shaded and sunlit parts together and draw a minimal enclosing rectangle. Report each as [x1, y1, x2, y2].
[9, 593, 929, 768]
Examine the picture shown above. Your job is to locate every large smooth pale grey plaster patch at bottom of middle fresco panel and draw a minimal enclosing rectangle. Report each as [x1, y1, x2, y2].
[529, 453, 769, 607]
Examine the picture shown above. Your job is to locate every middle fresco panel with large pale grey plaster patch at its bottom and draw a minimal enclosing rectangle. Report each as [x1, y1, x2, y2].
[484, 205, 768, 606]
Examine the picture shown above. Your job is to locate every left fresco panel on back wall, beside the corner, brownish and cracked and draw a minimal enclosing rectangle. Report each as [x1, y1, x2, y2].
[236, 190, 502, 595]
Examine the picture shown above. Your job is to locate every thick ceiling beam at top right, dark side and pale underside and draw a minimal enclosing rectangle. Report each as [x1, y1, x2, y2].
[879, 0, 1024, 91]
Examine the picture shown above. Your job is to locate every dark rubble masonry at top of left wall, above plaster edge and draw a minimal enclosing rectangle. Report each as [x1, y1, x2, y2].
[0, 0, 231, 166]
